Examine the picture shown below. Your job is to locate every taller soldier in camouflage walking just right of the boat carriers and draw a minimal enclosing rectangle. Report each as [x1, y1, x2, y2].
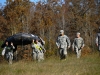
[56, 30, 70, 60]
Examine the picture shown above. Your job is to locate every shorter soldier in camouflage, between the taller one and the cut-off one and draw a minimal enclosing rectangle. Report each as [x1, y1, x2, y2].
[72, 32, 84, 58]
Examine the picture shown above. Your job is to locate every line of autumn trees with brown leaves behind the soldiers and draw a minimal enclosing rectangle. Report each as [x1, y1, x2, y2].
[0, 0, 100, 50]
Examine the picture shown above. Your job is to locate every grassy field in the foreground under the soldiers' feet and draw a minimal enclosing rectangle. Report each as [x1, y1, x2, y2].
[0, 53, 100, 75]
